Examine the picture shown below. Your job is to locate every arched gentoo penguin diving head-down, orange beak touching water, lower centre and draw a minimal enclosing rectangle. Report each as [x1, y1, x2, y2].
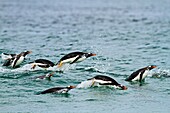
[88, 75, 127, 90]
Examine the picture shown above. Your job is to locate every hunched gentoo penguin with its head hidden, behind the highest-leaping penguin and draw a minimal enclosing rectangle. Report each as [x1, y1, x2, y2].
[31, 59, 55, 69]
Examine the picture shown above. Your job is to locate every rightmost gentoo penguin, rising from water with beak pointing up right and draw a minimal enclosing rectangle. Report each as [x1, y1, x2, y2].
[125, 65, 157, 82]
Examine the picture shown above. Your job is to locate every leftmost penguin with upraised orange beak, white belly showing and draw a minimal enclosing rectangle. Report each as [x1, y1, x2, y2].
[3, 51, 32, 68]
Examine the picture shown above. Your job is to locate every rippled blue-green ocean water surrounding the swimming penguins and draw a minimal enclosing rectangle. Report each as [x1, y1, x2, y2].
[0, 0, 170, 113]
